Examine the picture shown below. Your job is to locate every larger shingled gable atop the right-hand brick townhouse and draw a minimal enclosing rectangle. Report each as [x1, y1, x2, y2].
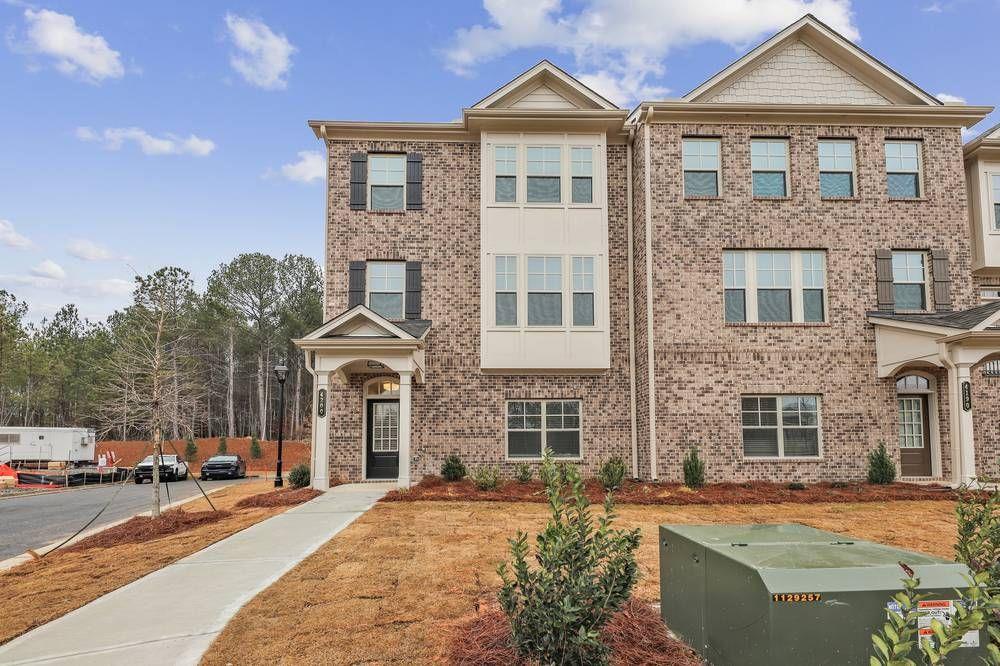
[683, 14, 942, 106]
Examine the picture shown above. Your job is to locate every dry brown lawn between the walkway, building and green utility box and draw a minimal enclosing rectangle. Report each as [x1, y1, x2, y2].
[204, 501, 955, 664]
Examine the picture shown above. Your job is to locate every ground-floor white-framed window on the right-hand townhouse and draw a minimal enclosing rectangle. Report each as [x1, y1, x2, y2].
[740, 395, 822, 458]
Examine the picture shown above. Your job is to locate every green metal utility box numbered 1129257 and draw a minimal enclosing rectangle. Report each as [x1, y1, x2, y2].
[660, 525, 988, 666]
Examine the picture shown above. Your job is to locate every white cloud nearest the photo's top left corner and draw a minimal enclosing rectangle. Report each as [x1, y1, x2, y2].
[14, 8, 125, 83]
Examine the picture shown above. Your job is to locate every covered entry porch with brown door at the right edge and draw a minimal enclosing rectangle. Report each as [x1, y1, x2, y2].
[868, 301, 1000, 484]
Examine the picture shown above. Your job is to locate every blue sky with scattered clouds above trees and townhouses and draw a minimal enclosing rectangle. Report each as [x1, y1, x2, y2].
[0, 0, 1000, 320]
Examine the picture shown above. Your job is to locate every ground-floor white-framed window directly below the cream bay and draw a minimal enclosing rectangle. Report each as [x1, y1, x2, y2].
[507, 400, 581, 458]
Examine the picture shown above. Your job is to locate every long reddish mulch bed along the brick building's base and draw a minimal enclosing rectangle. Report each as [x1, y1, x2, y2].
[382, 476, 956, 505]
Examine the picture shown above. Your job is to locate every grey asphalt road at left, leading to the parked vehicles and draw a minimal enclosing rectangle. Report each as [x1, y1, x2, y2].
[0, 479, 246, 560]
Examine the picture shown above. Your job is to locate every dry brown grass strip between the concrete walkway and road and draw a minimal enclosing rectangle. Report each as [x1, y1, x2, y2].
[0, 481, 287, 644]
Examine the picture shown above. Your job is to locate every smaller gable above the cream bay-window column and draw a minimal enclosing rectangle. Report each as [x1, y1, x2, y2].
[472, 60, 618, 111]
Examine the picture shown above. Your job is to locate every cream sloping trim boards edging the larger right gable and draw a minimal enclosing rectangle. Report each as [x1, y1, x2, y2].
[682, 14, 942, 106]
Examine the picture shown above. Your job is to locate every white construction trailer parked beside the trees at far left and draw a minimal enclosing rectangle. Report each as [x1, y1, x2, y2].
[0, 426, 97, 463]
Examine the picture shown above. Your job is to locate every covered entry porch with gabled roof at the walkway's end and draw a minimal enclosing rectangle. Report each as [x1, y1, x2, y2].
[294, 305, 431, 490]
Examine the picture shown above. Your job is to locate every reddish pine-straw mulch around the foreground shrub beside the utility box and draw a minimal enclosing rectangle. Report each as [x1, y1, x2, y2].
[447, 600, 704, 666]
